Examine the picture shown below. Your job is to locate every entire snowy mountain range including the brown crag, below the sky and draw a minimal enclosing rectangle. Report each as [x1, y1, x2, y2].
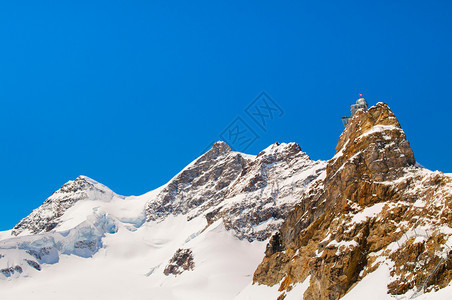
[0, 103, 452, 299]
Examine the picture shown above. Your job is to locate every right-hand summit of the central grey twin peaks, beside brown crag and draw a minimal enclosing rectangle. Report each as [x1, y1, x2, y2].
[214, 143, 326, 241]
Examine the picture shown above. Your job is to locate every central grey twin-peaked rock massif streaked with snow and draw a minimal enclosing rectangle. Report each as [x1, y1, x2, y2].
[146, 142, 325, 241]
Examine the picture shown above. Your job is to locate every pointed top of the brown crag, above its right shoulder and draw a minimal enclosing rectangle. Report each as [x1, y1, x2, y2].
[327, 102, 416, 181]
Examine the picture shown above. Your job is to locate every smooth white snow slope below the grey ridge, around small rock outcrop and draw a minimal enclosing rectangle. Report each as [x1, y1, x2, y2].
[0, 212, 265, 299]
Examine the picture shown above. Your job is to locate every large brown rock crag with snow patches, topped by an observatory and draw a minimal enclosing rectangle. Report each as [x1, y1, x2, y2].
[254, 103, 452, 299]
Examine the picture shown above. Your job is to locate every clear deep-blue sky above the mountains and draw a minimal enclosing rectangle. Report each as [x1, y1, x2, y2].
[0, 0, 452, 230]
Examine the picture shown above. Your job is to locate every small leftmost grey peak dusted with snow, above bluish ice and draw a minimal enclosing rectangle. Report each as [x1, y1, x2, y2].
[11, 176, 122, 236]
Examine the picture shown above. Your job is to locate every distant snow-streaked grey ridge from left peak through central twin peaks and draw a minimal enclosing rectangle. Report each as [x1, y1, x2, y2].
[12, 142, 325, 243]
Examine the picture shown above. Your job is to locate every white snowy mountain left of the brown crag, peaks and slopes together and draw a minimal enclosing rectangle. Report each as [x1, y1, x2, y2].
[0, 142, 326, 299]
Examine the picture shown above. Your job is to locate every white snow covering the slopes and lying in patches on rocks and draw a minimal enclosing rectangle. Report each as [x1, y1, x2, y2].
[0, 143, 452, 300]
